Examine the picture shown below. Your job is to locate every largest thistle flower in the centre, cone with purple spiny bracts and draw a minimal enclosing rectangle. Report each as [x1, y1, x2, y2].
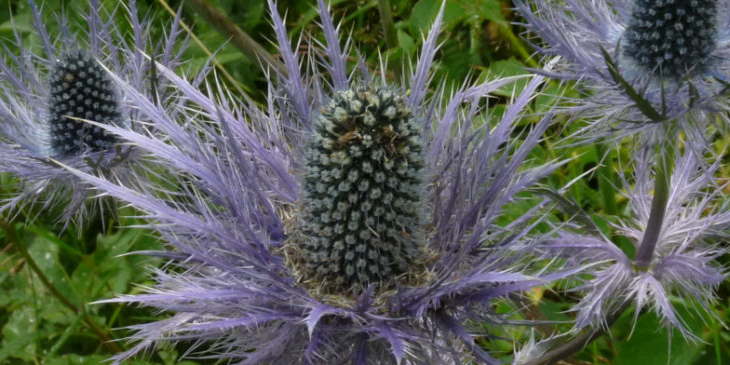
[75, 1, 559, 365]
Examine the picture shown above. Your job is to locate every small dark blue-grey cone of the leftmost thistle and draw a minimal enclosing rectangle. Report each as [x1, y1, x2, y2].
[48, 51, 122, 155]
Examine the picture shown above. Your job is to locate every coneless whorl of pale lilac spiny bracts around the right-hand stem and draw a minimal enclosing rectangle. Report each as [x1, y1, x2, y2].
[547, 150, 730, 339]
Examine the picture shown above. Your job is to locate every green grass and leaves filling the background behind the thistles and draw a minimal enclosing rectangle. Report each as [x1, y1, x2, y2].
[0, 0, 730, 365]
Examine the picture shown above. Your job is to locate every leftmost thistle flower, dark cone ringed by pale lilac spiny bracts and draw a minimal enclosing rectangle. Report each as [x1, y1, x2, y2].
[0, 0, 185, 224]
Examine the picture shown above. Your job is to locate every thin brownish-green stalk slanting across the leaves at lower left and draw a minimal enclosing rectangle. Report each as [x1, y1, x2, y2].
[0, 221, 124, 353]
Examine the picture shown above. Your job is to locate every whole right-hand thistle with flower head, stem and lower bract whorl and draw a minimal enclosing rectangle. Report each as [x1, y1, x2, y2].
[517, 0, 730, 358]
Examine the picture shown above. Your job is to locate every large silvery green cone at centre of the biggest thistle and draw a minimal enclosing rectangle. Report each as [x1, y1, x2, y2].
[300, 85, 425, 289]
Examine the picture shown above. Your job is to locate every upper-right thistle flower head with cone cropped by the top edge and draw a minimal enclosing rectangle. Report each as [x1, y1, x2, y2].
[517, 0, 730, 147]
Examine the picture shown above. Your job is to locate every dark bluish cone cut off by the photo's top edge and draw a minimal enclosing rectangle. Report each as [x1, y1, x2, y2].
[623, 0, 717, 77]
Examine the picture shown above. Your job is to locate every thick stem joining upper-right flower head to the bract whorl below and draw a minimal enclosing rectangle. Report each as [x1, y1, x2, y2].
[634, 144, 674, 270]
